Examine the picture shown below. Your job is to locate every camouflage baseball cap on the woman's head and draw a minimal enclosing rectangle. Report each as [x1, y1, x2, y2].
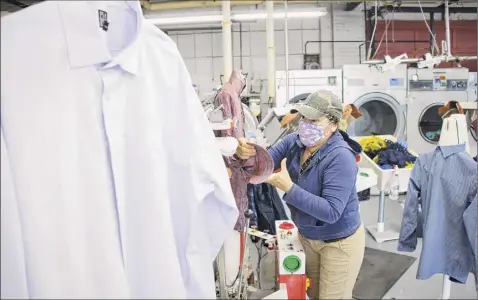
[291, 90, 343, 122]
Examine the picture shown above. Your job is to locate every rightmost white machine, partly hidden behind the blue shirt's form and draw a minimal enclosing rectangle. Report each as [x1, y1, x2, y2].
[407, 68, 476, 155]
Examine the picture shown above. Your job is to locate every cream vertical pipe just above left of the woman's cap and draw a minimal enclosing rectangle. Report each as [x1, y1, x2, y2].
[266, 1, 276, 105]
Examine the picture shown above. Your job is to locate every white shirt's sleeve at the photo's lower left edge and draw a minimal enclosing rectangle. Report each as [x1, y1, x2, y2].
[0, 125, 30, 299]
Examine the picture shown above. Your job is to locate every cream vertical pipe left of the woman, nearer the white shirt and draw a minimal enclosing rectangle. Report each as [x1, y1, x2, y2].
[222, 0, 232, 82]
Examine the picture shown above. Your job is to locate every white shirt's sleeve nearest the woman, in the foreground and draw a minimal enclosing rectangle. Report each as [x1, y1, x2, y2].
[170, 53, 239, 299]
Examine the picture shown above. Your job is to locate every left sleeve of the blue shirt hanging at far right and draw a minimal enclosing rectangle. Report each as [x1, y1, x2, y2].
[397, 157, 422, 252]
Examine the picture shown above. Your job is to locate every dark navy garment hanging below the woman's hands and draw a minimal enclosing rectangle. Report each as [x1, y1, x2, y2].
[248, 183, 289, 235]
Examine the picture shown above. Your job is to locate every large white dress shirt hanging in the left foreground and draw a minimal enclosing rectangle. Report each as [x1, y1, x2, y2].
[1, 1, 238, 299]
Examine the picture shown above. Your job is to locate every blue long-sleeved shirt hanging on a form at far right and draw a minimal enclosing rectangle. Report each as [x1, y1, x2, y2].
[398, 144, 477, 283]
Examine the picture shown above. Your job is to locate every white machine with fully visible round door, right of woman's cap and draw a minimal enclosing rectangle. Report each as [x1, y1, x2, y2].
[343, 65, 407, 140]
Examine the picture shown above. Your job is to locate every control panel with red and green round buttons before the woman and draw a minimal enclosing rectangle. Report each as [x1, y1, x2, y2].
[276, 221, 305, 275]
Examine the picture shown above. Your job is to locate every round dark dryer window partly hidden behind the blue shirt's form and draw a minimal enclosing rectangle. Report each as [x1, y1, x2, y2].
[418, 103, 443, 144]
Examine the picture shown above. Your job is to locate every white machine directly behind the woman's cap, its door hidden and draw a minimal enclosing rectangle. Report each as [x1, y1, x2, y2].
[276, 69, 342, 107]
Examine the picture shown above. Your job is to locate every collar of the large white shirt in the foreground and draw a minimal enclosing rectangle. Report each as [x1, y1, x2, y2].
[58, 0, 144, 75]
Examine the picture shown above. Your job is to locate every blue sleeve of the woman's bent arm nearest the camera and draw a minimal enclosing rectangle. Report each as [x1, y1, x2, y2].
[284, 148, 357, 224]
